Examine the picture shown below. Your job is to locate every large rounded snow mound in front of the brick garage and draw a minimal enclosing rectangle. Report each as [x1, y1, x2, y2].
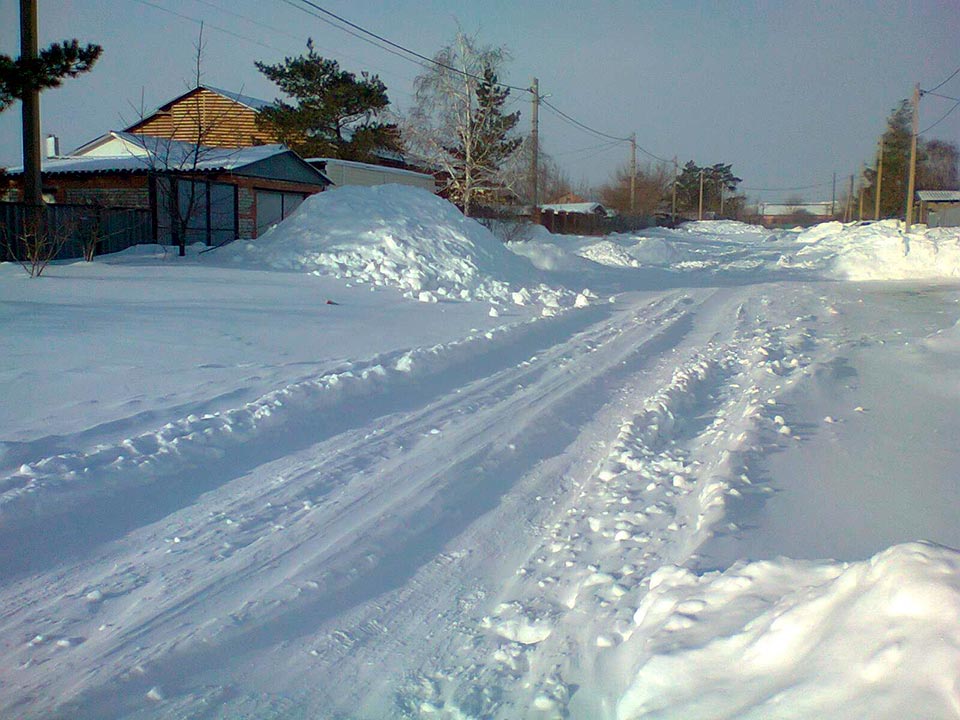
[233, 185, 573, 307]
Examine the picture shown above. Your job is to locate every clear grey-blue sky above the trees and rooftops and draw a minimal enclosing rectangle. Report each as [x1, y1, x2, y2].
[0, 0, 960, 200]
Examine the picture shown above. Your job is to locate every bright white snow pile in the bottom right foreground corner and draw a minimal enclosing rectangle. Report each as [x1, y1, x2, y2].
[616, 543, 960, 720]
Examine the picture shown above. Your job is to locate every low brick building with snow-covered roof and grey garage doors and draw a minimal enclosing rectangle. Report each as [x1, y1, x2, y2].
[0, 131, 330, 245]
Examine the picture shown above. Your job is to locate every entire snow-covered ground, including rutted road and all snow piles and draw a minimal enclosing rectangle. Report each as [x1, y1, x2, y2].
[0, 186, 960, 720]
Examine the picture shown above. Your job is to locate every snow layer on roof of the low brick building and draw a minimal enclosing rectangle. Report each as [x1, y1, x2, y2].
[7, 131, 290, 174]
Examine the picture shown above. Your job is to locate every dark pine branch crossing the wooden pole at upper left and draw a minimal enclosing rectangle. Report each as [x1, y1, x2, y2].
[0, 40, 103, 112]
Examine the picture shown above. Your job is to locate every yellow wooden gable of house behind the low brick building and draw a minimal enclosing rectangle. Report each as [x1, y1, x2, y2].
[124, 85, 278, 148]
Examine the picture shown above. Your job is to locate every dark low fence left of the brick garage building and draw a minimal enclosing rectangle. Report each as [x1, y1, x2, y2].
[0, 202, 156, 260]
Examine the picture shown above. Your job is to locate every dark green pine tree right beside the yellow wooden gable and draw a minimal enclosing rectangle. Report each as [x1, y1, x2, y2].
[255, 40, 399, 161]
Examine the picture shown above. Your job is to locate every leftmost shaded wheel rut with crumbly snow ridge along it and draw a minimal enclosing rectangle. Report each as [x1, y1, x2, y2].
[0, 304, 614, 580]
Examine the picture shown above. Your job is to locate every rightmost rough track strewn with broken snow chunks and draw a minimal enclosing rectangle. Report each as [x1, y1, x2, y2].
[401, 290, 809, 718]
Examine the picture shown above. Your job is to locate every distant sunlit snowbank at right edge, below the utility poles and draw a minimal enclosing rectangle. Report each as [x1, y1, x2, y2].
[780, 220, 960, 280]
